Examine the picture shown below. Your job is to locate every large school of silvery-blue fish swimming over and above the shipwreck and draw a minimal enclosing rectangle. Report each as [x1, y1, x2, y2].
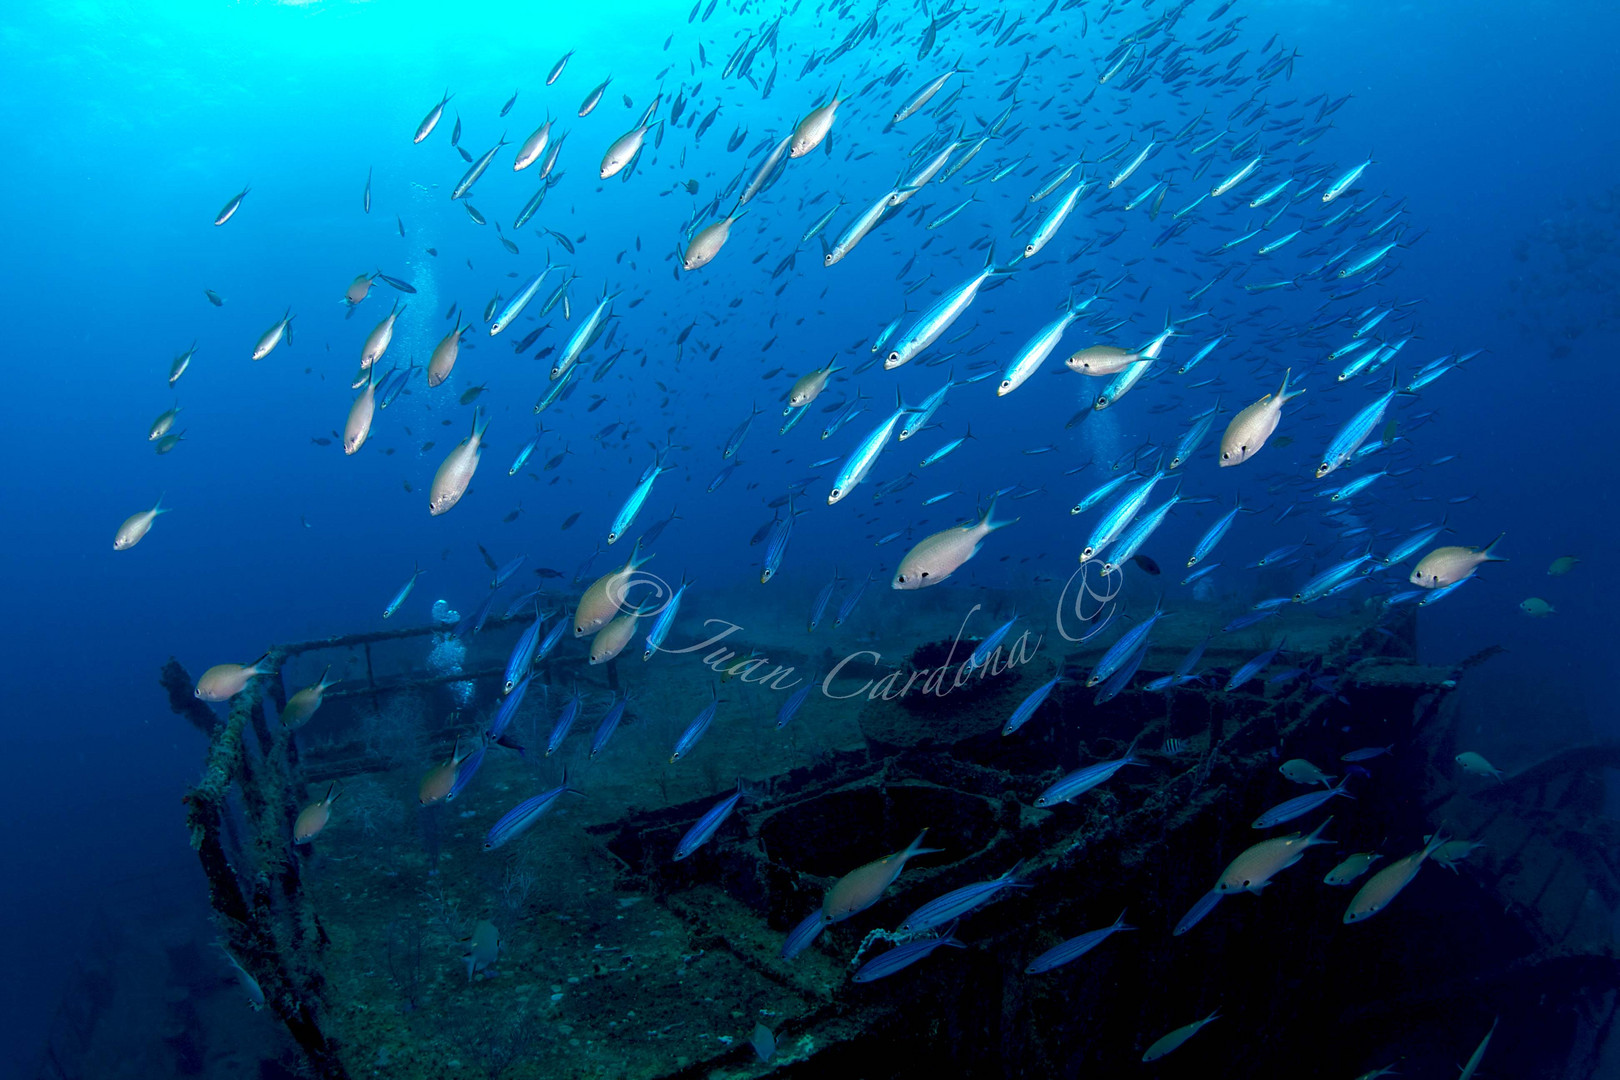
[129, 0, 1529, 1064]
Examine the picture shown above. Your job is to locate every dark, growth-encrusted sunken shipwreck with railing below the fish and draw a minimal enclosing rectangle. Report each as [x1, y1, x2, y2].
[164, 608, 1620, 1080]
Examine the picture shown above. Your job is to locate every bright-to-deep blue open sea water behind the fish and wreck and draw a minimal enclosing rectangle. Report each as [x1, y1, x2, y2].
[0, 0, 1620, 1075]
